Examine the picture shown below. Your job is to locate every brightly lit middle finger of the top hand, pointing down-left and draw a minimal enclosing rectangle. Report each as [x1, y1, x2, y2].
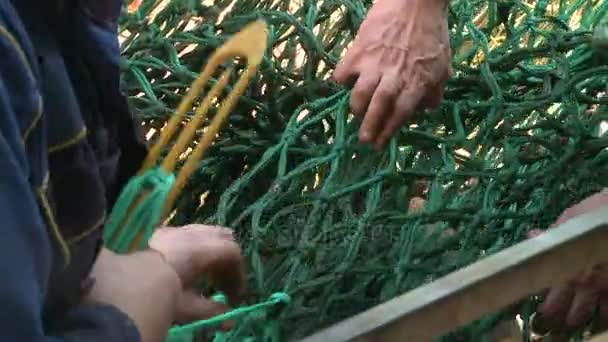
[359, 78, 402, 143]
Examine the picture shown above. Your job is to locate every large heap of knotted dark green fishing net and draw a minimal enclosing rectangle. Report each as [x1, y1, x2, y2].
[120, 0, 608, 341]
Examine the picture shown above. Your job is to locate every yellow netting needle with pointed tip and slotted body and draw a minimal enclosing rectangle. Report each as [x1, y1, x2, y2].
[121, 20, 268, 251]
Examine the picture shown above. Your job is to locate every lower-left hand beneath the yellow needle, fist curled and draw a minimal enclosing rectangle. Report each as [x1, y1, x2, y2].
[87, 225, 245, 342]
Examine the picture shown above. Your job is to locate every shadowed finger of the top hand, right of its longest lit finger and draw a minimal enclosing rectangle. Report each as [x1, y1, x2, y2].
[375, 82, 424, 148]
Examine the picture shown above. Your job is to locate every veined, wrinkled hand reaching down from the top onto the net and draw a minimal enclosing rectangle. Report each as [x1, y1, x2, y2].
[334, 0, 452, 148]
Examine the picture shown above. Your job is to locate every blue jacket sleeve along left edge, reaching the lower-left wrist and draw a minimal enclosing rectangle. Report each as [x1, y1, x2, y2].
[0, 2, 140, 342]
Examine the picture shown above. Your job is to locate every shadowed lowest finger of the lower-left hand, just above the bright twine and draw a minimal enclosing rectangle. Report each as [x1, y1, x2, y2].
[176, 291, 234, 330]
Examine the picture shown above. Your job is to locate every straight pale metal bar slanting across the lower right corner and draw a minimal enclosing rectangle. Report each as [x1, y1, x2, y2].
[300, 210, 608, 342]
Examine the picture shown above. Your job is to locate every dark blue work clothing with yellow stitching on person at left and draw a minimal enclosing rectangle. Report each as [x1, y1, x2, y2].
[0, 0, 146, 342]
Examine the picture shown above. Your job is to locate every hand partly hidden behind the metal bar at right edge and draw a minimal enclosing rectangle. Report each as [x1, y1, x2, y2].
[529, 192, 608, 330]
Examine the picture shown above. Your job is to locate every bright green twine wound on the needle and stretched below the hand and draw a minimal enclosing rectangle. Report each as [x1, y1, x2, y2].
[104, 167, 290, 342]
